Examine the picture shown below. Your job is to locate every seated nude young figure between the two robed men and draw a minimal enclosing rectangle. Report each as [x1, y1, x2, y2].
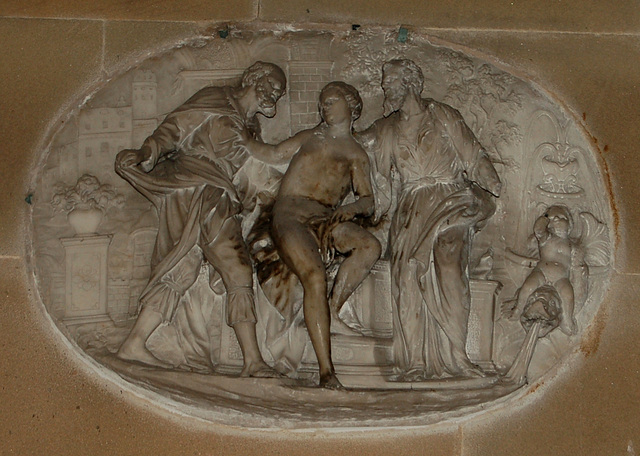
[249, 82, 381, 388]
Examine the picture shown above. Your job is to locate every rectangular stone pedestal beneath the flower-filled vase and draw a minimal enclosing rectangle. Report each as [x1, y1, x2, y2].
[60, 235, 111, 325]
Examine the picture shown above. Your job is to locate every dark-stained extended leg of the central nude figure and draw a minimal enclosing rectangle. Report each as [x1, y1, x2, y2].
[273, 216, 340, 388]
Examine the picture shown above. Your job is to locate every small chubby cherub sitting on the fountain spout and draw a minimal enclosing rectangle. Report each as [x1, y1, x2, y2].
[510, 204, 577, 335]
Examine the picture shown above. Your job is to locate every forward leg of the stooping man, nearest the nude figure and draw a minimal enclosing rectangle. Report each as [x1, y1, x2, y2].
[202, 218, 280, 377]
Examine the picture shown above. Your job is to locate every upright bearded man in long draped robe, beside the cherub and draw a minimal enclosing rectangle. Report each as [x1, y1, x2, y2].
[359, 60, 501, 381]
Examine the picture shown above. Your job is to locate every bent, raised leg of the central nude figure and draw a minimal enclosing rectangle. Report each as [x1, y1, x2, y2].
[329, 222, 382, 335]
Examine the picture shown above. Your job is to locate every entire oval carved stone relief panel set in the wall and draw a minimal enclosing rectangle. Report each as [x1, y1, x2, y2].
[32, 29, 612, 428]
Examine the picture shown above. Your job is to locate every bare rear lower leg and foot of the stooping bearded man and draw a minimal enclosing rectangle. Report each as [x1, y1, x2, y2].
[116, 307, 172, 368]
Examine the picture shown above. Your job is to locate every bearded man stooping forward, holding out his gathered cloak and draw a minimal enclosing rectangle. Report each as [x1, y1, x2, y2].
[115, 62, 286, 377]
